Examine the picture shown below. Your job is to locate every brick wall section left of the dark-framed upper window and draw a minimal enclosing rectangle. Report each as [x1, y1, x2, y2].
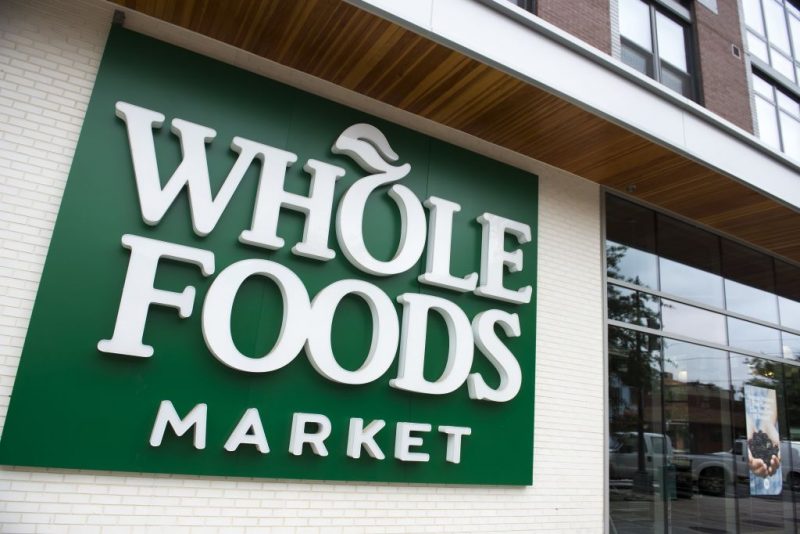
[536, 0, 611, 54]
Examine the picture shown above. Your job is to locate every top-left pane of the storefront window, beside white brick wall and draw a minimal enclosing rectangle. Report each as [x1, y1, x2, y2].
[606, 196, 658, 289]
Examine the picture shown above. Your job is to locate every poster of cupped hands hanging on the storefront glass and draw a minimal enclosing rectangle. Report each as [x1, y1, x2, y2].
[744, 386, 783, 495]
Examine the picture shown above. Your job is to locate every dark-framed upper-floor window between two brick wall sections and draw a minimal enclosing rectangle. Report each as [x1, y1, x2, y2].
[619, 0, 695, 99]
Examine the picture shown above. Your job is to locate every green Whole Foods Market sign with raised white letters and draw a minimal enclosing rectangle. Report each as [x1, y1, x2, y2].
[0, 29, 537, 490]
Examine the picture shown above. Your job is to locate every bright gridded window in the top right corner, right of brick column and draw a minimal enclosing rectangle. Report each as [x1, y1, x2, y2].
[742, 0, 800, 85]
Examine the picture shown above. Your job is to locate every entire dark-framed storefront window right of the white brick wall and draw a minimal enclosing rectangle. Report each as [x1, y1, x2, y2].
[606, 197, 800, 533]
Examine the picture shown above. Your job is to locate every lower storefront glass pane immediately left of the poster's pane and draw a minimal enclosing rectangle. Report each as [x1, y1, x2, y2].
[663, 338, 736, 532]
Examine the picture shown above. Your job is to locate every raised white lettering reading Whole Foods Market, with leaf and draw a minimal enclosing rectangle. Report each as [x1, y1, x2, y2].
[97, 102, 532, 463]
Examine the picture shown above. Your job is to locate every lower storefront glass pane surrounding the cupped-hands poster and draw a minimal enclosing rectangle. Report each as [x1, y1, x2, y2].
[730, 354, 795, 534]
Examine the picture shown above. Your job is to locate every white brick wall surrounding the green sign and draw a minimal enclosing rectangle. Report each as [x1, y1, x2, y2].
[0, 0, 605, 533]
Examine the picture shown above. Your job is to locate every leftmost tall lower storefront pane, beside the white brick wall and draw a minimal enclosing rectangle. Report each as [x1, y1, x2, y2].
[608, 327, 673, 533]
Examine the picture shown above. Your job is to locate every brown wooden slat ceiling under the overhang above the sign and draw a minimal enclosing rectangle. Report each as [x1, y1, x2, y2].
[114, 0, 800, 262]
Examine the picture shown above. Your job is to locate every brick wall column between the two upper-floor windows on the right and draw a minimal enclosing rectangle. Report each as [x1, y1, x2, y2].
[695, 0, 753, 132]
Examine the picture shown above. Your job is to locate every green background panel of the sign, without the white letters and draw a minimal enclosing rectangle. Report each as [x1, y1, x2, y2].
[0, 28, 538, 485]
